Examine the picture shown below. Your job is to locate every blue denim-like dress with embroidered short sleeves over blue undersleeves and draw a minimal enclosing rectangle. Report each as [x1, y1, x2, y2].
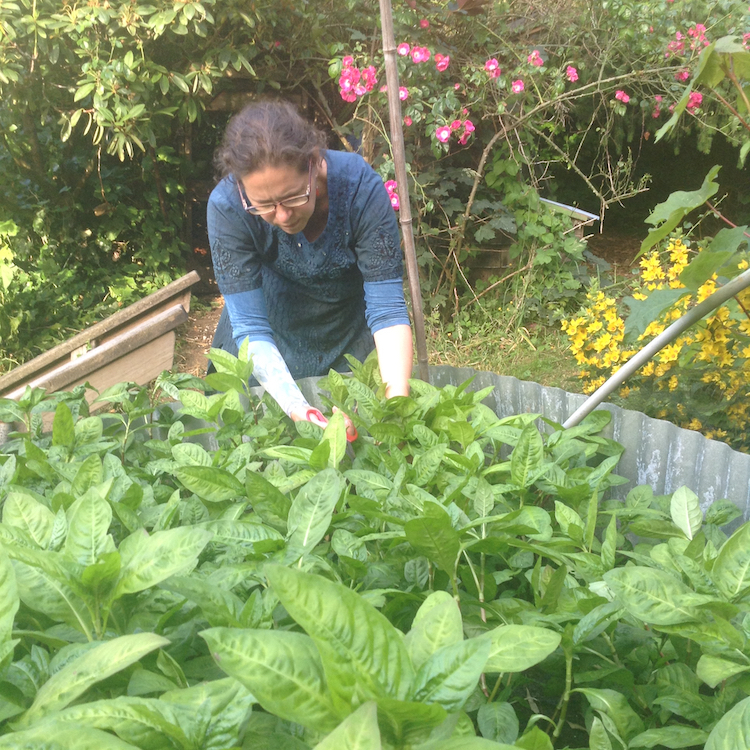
[208, 151, 409, 379]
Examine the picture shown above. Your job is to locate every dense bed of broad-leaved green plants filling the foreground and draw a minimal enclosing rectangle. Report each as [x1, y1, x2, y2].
[0, 352, 750, 750]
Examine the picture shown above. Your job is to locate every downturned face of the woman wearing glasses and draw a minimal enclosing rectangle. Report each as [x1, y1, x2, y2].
[240, 160, 318, 234]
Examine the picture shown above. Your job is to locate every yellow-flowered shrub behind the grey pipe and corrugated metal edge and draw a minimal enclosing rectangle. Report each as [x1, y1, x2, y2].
[562, 237, 750, 451]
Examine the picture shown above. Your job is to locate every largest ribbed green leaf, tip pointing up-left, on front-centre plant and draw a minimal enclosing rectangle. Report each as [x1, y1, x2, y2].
[266, 565, 414, 704]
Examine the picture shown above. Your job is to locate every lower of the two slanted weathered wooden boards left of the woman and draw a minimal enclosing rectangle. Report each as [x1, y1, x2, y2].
[0, 304, 188, 398]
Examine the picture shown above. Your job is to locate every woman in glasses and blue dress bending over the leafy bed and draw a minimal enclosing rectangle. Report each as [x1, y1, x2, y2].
[208, 101, 412, 428]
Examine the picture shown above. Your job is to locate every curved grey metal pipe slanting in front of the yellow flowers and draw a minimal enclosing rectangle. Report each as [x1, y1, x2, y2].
[563, 269, 750, 428]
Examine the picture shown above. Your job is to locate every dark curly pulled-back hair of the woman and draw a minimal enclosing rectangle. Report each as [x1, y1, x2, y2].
[214, 100, 326, 179]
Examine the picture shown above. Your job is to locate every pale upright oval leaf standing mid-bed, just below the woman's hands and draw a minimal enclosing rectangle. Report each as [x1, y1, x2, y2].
[287, 468, 343, 553]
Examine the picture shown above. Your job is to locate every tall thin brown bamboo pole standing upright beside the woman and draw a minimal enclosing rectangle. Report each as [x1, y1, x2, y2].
[380, 0, 430, 382]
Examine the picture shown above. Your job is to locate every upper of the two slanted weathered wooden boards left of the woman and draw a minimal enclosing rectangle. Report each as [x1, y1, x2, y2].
[0, 271, 200, 393]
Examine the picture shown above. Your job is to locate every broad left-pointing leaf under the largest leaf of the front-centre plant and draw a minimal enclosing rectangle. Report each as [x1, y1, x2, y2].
[201, 628, 341, 732]
